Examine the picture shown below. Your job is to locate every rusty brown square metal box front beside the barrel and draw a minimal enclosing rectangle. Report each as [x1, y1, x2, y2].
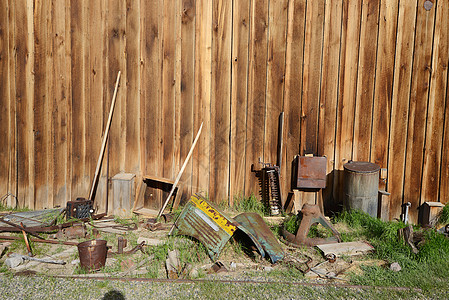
[296, 156, 327, 189]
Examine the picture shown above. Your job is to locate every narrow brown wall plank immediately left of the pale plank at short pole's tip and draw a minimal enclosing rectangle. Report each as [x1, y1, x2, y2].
[179, 0, 196, 199]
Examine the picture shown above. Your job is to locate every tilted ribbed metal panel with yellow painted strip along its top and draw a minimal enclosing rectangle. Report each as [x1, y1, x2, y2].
[170, 195, 237, 261]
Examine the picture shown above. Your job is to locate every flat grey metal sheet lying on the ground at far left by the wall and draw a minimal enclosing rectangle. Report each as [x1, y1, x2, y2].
[2, 208, 64, 227]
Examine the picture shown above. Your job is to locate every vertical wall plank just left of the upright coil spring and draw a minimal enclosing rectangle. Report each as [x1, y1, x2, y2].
[245, 0, 268, 195]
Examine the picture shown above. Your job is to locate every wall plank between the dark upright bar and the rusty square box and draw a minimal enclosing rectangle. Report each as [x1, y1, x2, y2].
[281, 0, 306, 199]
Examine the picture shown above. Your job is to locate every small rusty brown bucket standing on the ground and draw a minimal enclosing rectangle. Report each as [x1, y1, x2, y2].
[78, 240, 108, 271]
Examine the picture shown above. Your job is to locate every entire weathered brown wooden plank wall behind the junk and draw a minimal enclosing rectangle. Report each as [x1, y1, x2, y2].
[0, 0, 449, 221]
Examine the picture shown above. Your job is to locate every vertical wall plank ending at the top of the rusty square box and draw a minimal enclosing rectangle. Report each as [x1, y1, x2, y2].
[301, 1, 324, 155]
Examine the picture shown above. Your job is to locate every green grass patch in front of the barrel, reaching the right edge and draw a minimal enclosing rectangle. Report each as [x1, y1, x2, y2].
[334, 211, 449, 293]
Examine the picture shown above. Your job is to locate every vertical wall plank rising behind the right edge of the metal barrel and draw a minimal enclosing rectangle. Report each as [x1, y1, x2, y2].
[370, 0, 398, 221]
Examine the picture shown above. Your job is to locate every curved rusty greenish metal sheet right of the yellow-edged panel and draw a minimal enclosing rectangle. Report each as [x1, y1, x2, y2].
[234, 213, 284, 263]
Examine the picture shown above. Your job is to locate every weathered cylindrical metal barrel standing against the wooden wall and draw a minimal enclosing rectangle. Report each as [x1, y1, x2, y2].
[343, 161, 380, 218]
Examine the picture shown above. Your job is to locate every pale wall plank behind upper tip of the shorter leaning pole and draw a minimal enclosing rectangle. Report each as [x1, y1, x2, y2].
[192, 0, 212, 193]
